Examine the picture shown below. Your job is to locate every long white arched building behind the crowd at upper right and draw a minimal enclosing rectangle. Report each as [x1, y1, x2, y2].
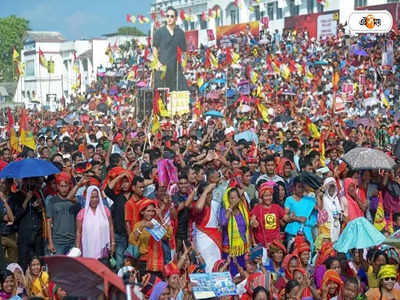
[151, 0, 399, 44]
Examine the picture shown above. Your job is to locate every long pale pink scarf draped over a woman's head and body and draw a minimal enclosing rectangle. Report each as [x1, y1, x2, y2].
[82, 185, 110, 259]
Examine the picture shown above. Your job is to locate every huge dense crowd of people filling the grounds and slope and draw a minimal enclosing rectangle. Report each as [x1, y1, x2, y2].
[0, 7, 400, 300]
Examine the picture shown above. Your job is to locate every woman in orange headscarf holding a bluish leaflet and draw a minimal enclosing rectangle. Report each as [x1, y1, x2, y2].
[129, 199, 172, 277]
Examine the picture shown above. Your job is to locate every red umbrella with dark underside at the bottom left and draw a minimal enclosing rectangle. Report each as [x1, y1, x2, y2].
[44, 255, 138, 299]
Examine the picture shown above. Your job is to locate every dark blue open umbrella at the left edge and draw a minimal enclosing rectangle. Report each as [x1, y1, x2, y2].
[0, 158, 60, 178]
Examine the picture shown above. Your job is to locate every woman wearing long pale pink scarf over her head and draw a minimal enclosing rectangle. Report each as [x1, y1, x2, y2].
[75, 185, 115, 259]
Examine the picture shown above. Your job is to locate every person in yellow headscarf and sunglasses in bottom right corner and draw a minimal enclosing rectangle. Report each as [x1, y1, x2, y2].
[365, 265, 400, 300]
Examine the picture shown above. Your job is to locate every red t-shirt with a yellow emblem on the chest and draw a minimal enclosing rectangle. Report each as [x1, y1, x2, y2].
[251, 204, 285, 246]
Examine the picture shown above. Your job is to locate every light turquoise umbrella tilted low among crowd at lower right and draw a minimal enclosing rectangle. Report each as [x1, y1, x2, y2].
[333, 217, 386, 253]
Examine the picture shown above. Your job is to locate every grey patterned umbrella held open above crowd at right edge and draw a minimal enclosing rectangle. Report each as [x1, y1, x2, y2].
[342, 147, 396, 170]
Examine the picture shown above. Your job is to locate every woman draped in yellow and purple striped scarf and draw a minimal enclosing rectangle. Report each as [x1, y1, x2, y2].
[218, 188, 250, 276]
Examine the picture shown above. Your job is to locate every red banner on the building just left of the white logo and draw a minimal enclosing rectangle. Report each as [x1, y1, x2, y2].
[285, 10, 339, 38]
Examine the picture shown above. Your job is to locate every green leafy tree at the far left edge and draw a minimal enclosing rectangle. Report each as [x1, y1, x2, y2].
[0, 15, 29, 81]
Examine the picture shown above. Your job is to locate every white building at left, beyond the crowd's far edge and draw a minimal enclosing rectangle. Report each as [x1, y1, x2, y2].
[14, 31, 146, 110]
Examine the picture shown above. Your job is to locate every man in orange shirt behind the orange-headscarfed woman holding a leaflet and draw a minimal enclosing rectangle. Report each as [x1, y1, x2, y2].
[125, 176, 144, 236]
